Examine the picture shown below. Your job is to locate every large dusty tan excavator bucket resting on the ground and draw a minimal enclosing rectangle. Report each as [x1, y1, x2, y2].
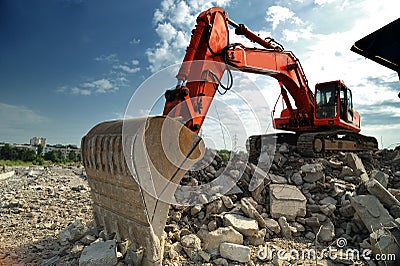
[81, 116, 205, 265]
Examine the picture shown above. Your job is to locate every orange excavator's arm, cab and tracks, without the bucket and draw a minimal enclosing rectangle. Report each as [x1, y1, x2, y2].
[163, 8, 377, 160]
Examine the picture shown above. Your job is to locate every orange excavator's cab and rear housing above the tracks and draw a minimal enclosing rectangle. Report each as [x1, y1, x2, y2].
[315, 80, 360, 131]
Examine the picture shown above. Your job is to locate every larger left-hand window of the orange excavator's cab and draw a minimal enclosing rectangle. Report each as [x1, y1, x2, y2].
[315, 83, 338, 118]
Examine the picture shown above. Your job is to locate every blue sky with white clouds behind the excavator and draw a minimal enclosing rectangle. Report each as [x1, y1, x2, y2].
[0, 0, 400, 148]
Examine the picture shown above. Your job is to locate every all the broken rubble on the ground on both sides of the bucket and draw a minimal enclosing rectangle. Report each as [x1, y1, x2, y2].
[0, 144, 400, 266]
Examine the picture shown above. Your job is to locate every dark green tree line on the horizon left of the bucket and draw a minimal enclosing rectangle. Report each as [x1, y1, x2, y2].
[0, 144, 81, 164]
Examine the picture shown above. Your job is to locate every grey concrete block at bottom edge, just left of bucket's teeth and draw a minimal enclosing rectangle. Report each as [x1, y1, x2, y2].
[79, 239, 118, 266]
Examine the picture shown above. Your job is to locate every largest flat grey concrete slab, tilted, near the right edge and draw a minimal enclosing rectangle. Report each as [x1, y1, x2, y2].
[350, 195, 394, 233]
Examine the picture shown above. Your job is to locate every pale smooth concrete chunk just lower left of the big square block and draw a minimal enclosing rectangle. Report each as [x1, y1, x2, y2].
[224, 213, 258, 236]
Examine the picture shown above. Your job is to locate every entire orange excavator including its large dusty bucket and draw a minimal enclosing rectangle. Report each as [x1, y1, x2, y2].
[81, 7, 377, 265]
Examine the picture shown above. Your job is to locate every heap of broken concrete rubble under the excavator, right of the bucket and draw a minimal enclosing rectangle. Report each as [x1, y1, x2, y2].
[164, 147, 400, 265]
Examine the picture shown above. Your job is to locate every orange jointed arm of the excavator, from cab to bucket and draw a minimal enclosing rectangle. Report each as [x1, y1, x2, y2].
[163, 7, 314, 133]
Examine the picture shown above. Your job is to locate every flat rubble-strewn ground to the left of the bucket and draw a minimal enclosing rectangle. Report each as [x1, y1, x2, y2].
[0, 165, 96, 265]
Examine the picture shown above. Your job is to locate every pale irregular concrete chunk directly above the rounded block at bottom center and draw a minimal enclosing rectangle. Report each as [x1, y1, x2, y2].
[198, 226, 243, 254]
